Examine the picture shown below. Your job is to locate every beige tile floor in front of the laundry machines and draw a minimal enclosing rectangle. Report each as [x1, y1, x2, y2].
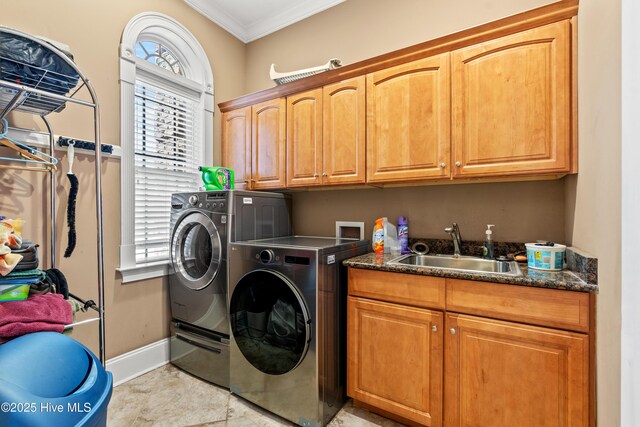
[107, 364, 401, 427]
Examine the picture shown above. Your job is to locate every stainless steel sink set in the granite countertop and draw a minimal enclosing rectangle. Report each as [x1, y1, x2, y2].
[389, 254, 522, 276]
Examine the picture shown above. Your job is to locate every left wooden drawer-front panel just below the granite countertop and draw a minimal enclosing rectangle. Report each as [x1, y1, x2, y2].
[348, 268, 445, 309]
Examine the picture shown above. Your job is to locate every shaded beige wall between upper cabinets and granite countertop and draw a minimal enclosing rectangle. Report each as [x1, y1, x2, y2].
[293, 181, 565, 242]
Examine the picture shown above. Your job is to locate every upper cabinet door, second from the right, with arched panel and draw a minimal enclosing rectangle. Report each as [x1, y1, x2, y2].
[367, 53, 450, 182]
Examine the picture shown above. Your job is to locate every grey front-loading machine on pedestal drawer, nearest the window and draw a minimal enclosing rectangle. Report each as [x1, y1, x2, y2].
[169, 190, 291, 387]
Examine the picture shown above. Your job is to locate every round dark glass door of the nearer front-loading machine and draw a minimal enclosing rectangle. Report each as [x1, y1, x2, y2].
[229, 270, 311, 375]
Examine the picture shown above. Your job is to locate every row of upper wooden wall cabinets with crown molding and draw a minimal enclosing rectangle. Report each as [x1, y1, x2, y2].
[219, 0, 578, 189]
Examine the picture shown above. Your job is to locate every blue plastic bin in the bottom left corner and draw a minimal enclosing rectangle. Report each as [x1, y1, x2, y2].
[0, 332, 113, 427]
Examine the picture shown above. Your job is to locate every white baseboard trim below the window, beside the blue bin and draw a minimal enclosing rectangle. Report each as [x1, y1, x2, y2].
[107, 338, 169, 386]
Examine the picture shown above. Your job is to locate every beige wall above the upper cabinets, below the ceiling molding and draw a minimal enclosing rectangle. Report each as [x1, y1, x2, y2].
[246, 0, 553, 92]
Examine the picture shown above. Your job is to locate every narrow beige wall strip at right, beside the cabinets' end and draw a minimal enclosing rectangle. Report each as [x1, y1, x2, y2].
[566, 0, 621, 427]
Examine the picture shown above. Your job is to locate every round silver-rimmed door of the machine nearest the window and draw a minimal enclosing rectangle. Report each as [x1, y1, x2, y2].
[171, 212, 222, 290]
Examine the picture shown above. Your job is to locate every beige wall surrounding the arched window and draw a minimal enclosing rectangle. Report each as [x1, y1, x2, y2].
[0, 0, 245, 357]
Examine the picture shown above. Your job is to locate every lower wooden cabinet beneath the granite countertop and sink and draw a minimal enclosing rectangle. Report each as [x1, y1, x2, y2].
[347, 268, 595, 427]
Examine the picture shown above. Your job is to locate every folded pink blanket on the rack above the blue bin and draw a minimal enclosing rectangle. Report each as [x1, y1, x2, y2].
[0, 294, 73, 342]
